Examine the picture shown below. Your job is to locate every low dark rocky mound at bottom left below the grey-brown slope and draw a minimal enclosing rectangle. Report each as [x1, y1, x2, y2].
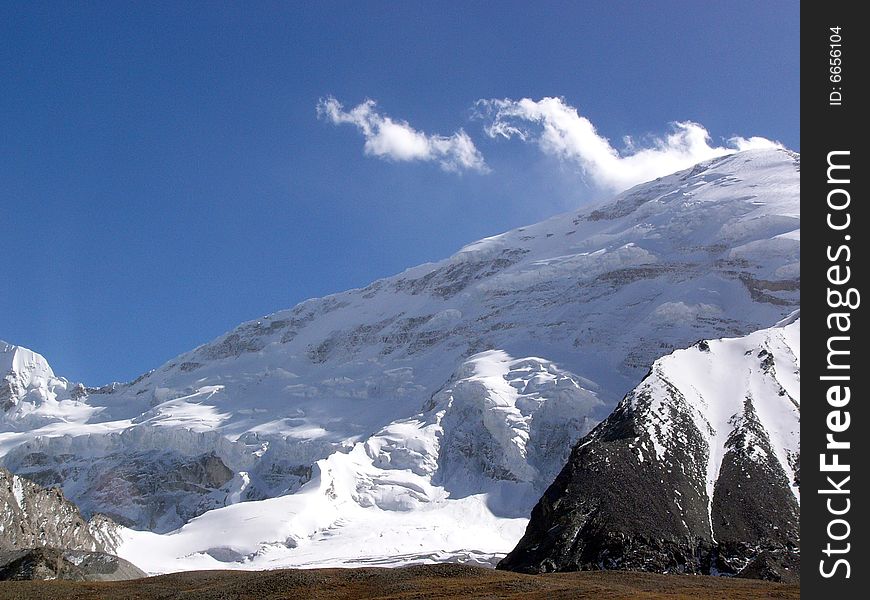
[0, 548, 146, 581]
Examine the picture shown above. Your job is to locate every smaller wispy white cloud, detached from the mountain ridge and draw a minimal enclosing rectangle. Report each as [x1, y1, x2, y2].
[317, 96, 489, 173]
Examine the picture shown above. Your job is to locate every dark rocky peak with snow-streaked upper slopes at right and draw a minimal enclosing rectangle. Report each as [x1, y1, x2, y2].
[498, 314, 800, 578]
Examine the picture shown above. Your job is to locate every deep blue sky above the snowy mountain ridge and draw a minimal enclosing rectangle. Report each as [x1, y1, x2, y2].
[0, 0, 800, 385]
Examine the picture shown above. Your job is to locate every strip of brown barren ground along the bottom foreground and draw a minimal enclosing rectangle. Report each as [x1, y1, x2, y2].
[0, 564, 800, 600]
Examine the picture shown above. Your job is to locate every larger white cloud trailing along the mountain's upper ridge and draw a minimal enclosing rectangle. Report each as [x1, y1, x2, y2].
[477, 98, 782, 191]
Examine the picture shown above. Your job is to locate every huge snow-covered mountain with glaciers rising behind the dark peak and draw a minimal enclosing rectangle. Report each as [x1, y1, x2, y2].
[0, 150, 800, 570]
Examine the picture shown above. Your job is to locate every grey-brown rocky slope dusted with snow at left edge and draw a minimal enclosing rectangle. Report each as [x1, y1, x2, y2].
[0, 468, 117, 552]
